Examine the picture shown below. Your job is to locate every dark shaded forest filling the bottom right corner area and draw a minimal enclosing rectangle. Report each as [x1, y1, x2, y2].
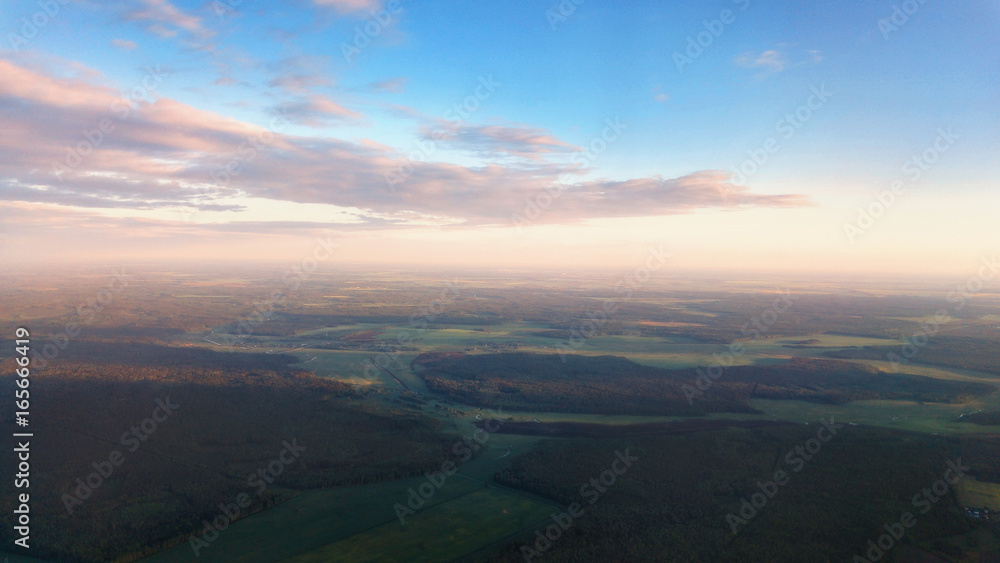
[489, 428, 998, 563]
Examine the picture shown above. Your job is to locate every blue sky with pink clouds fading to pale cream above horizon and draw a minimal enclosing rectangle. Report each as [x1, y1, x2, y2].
[0, 0, 1000, 278]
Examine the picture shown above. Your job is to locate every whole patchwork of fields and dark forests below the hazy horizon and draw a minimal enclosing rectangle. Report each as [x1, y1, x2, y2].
[3, 272, 1000, 561]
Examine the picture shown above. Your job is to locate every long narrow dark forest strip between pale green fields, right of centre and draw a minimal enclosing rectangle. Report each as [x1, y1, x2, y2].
[413, 353, 996, 416]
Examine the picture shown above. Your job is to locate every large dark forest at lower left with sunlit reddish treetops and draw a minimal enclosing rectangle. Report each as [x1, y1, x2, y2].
[0, 348, 451, 562]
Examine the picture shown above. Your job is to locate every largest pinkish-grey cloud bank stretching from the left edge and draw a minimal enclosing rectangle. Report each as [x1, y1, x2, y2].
[0, 60, 810, 226]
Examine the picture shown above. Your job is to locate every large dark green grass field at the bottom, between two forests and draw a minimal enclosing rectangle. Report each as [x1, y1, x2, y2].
[144, 415, 553, 563]
